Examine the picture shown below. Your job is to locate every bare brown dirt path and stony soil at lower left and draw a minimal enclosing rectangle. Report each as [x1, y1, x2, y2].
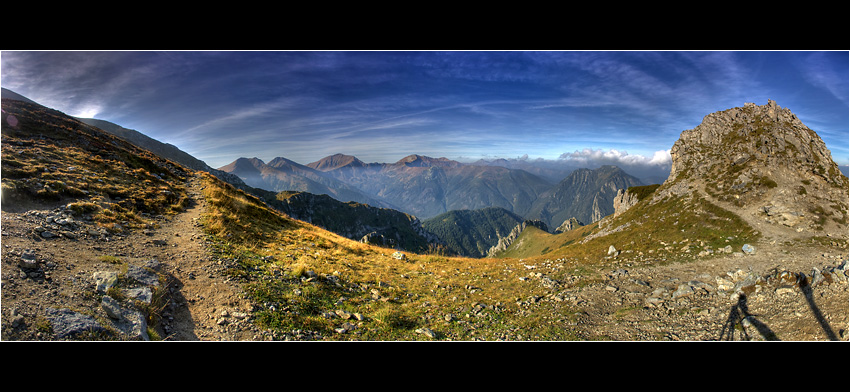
[0, 173, 264, 341]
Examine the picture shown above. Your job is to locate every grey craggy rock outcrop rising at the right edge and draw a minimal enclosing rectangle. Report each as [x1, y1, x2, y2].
[654, 100, 848, 234]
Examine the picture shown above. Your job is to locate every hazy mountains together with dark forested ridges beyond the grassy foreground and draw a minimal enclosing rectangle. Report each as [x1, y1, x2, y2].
[219, 150, 643, 257]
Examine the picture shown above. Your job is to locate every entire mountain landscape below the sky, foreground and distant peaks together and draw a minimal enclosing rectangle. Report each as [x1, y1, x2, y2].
[1, 90, 850, 341]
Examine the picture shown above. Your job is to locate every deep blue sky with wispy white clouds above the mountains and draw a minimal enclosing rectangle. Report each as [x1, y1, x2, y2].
[0, 51, 850, 171]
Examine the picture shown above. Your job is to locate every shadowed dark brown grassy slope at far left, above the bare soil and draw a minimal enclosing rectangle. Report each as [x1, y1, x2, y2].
[2, 100, 187, 231]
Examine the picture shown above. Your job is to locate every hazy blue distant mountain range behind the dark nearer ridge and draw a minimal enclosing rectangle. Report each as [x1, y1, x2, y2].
[220, 154, 643, 227]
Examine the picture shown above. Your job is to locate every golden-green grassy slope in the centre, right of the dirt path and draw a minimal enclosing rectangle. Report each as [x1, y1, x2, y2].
[198, 172, 596, 340]
